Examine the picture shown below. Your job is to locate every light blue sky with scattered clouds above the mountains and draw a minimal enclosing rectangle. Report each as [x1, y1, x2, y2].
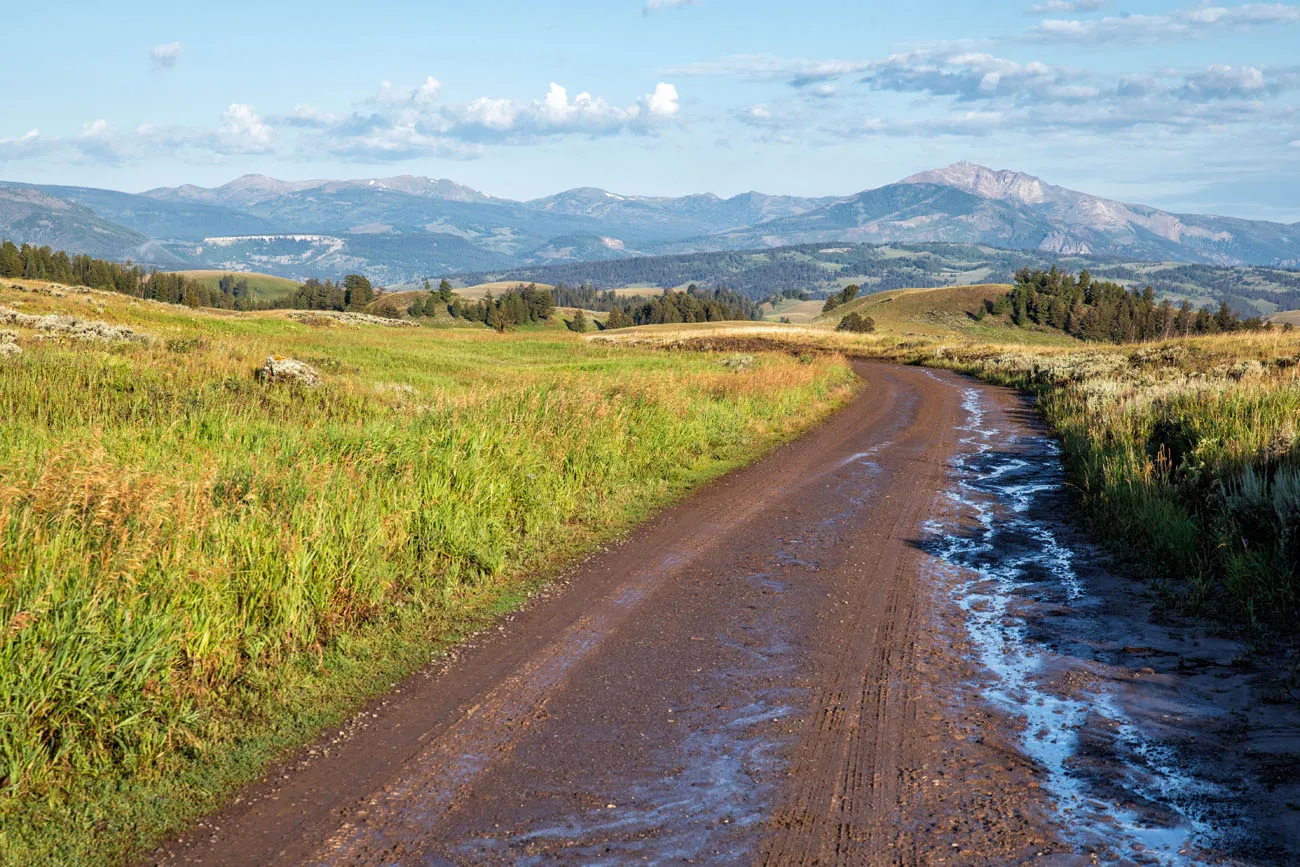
[0, 0, 1300, 222]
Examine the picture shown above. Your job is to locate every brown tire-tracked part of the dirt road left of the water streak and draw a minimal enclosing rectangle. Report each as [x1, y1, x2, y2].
[151, 363, 1058, 864]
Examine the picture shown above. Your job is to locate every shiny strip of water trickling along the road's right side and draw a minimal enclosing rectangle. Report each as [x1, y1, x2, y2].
[924, 389, 1239, 866]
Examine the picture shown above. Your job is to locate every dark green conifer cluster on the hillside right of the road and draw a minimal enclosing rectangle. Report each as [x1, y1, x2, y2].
[993, 265, 1269, 343]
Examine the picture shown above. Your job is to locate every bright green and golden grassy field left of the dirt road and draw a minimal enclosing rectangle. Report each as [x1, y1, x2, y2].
[0, 285, 853, 864]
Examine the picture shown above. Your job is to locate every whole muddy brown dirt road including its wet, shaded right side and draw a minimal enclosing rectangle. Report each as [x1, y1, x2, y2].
[152, 364, 1300, 864]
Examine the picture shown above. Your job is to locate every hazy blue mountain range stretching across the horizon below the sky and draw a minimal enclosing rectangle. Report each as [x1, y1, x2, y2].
[0, 162, 1300, 283]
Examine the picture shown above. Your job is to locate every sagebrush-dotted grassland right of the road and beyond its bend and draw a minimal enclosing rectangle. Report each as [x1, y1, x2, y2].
[593, 301, 1300, 632]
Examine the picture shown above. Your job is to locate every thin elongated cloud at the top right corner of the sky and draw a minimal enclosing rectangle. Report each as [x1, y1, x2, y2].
[1024, 3, 1300, 43]
